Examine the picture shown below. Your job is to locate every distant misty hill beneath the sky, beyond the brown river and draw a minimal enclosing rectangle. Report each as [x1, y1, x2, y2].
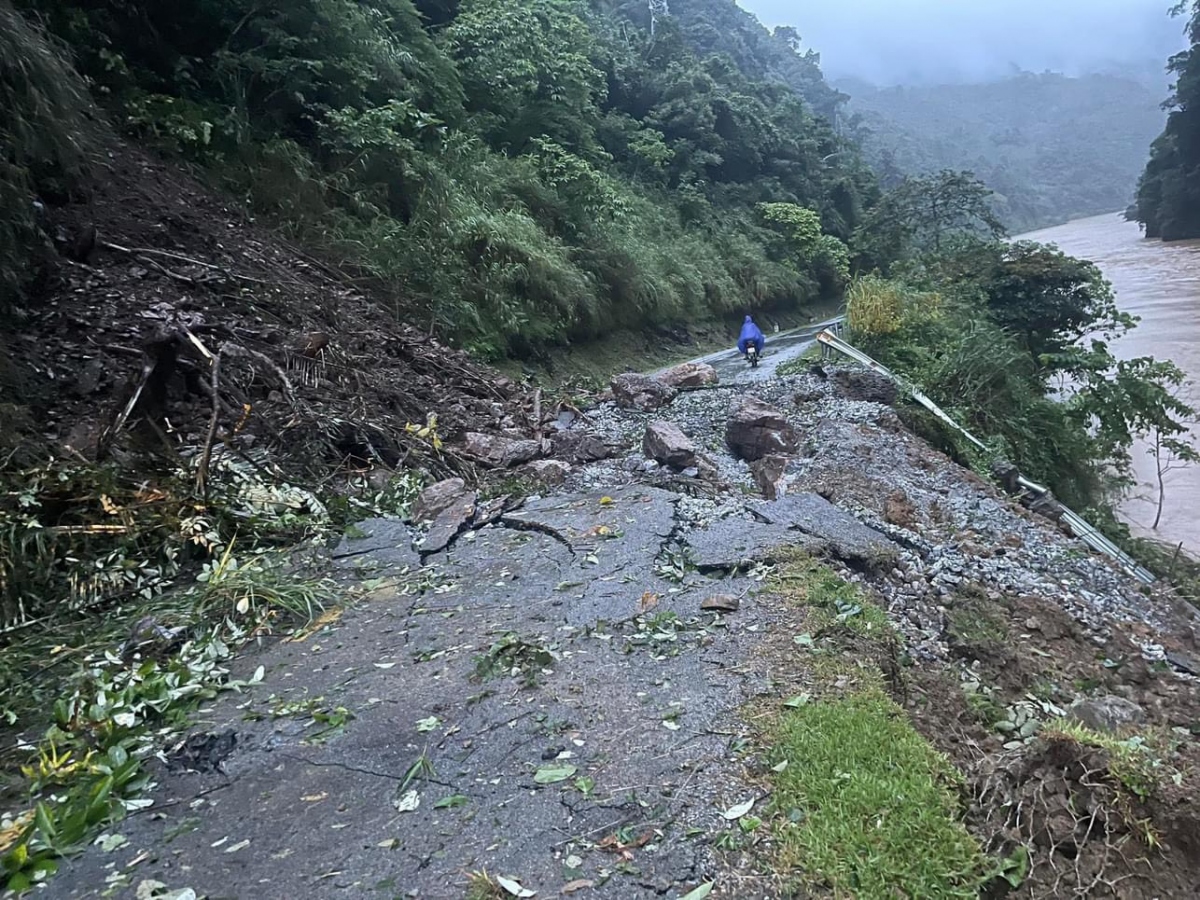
[840, 73, 1164, 233]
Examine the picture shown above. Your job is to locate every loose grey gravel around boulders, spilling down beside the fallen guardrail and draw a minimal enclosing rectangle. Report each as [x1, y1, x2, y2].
[556, 374, 1195, 660]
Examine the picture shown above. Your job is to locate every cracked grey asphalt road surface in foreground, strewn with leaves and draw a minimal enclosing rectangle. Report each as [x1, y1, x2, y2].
[49, 486, 892, 900]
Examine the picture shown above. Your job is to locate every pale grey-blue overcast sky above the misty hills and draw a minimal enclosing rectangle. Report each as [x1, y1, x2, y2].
[737, 0, 1184, 84]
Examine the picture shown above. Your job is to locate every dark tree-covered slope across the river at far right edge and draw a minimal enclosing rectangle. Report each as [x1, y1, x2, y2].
[1135, 0, 1200, 240]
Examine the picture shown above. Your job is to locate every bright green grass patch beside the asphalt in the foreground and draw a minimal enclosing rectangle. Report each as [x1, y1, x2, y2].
[774, 690, 989, 900]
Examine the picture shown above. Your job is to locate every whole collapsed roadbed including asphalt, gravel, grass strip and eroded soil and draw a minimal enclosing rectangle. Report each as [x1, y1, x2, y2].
[35, 362, 1200, 898]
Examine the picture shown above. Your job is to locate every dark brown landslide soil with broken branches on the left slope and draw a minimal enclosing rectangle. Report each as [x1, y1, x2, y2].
[0, 143, 535, 487]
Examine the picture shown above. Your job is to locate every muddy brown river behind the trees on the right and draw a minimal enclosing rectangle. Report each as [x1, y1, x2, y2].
[1020, 214, 1200, 553]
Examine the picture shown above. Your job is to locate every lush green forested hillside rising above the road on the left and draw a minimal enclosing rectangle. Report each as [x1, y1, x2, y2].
[4, 0, 877, 355]
